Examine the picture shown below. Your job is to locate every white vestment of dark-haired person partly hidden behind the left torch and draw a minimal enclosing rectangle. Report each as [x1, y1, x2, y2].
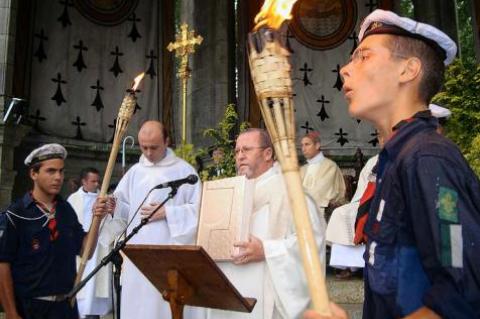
[67, 187, 112, 317]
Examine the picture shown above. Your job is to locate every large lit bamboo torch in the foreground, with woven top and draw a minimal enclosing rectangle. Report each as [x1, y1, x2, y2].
[248, 0, 330, 315]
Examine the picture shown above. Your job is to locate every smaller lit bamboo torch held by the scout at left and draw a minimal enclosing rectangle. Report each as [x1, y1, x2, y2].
[72, 73, 145, 304]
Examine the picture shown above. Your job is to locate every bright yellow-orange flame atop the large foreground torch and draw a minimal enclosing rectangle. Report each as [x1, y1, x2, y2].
[254, 0, 297, 30]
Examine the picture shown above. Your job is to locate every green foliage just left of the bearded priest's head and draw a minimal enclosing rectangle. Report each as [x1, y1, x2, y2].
[201, 104, 249, 180]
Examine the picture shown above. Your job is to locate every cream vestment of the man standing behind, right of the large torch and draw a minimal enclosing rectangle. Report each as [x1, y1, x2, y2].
[300, 152, 346, 215]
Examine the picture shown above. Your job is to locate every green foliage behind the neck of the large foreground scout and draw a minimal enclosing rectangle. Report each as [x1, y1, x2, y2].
[433, 59, 480, 178]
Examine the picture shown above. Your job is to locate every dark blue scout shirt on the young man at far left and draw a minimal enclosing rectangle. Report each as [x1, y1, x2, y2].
[0, 193, 85, 298]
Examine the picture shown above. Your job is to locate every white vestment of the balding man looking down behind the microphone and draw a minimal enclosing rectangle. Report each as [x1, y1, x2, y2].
[100, 149, 201, 319]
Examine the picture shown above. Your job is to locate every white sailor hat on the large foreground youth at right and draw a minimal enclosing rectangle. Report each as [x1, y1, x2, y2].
[358, 9, 457, 65]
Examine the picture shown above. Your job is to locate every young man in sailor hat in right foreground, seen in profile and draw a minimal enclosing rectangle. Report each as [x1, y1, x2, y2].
[305, 6, 480, 319]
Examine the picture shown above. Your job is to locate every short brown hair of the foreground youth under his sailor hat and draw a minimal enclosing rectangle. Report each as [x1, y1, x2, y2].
[385, 35, 445, 104]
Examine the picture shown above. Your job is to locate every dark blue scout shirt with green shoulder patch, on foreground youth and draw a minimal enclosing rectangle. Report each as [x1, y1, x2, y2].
[364, 112, 480, 319]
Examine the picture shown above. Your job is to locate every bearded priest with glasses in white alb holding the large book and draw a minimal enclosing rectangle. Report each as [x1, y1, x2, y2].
[207, 129, 326, 319]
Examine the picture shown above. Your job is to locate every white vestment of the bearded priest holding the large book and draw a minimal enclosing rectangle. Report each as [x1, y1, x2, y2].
[207, 167, 326, 319]
